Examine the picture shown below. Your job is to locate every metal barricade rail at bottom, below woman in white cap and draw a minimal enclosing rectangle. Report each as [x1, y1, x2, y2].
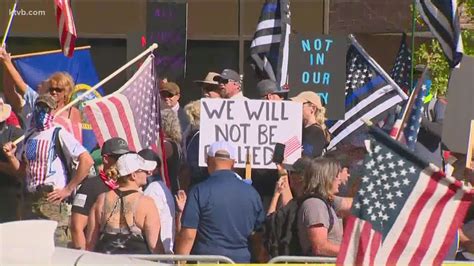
[124, 254, 235, 264]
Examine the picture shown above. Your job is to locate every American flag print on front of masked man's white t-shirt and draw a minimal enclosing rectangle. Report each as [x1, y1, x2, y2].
[25, 139, 51, 187]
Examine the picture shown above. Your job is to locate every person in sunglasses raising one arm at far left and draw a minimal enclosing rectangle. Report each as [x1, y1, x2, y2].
[0, 47, 82, 132]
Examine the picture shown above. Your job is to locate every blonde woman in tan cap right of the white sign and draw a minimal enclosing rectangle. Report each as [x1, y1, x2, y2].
[291, 91, 331, 158]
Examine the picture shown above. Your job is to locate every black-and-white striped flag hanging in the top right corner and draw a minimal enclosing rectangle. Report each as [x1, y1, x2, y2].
[416, 0, 464, 67]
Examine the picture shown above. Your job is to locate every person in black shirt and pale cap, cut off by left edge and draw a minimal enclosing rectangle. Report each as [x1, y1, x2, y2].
[0, 98, 23, 223]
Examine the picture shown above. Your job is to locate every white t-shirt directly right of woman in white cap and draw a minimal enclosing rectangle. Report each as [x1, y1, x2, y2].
[145, 181, 175, 254]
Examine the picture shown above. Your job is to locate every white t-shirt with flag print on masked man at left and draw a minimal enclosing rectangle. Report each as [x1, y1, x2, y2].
[21, 127, 87, 192]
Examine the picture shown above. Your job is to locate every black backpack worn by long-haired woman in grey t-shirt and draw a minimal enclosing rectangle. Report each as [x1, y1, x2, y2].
[264, 195, 334, 257]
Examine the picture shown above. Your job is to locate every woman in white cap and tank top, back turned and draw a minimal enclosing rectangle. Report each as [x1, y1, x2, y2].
[87, 153, 163, 254]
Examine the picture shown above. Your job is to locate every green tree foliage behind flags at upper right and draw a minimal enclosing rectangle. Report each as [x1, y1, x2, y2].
[414, 0, 474, 95]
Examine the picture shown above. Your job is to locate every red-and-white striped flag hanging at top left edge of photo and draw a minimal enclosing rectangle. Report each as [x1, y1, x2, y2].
[54, 0, 77, 57]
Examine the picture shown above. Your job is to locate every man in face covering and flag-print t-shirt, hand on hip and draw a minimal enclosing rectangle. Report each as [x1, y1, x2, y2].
[3, 94, 94, 246]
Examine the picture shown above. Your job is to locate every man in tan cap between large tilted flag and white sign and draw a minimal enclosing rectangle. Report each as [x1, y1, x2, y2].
[160, 82, 189, 132]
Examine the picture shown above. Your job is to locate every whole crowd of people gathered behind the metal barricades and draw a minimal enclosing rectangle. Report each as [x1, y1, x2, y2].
[0, 44, 473, 262]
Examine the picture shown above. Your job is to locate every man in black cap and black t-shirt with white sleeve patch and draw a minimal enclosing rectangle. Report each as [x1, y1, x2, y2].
[71, 138, 130, 249]
